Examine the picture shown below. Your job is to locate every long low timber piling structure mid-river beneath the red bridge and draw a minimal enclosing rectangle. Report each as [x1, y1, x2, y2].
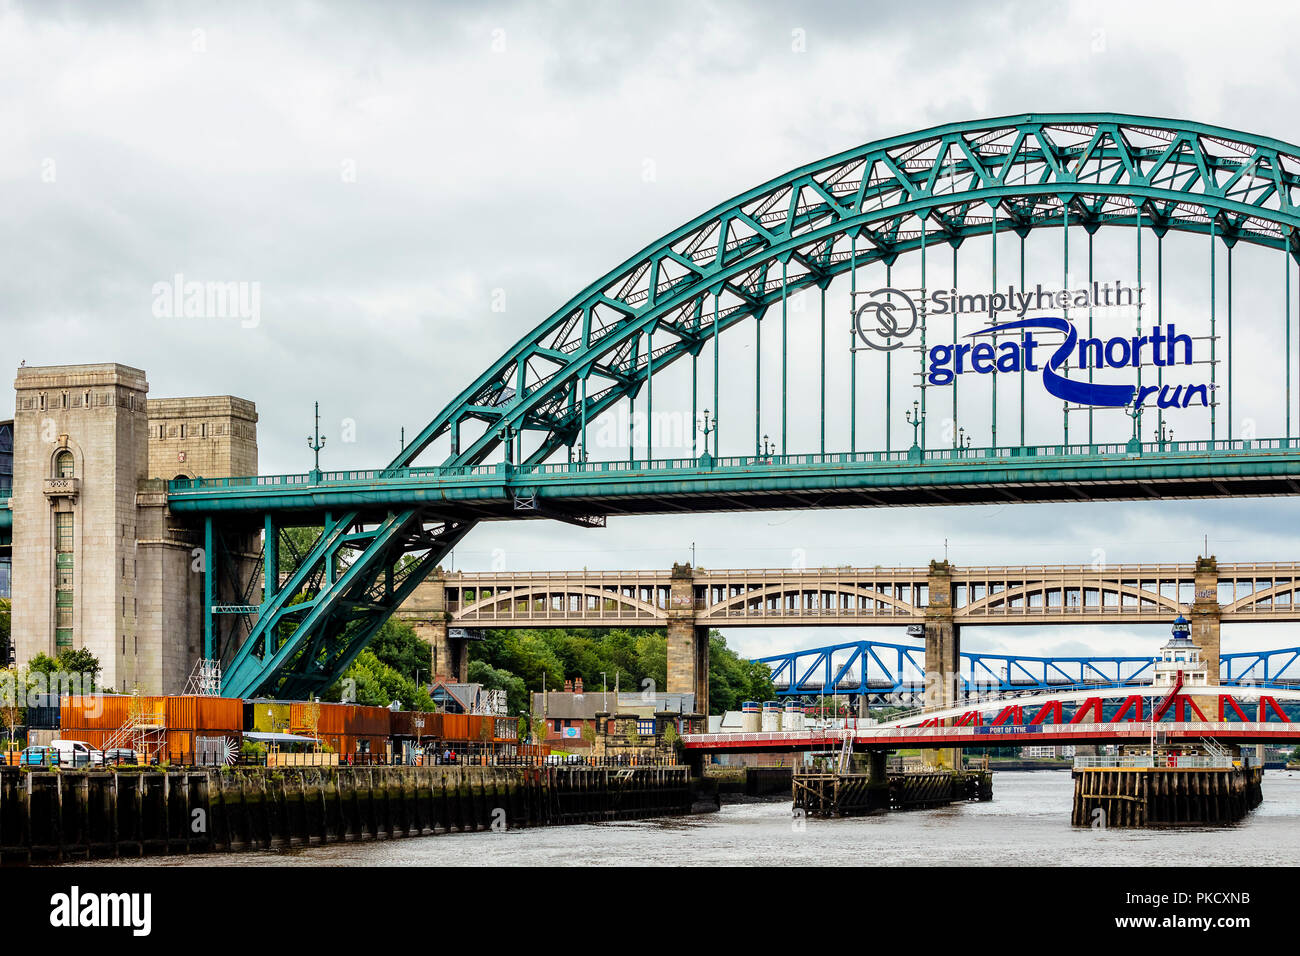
[792, 770, 993, 817]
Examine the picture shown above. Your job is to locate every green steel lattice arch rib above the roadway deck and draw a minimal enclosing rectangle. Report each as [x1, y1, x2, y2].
[390, 113, 1300, 468]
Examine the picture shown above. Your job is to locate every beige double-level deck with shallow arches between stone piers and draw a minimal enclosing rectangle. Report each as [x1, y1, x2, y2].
[423, 562, 1300, 627]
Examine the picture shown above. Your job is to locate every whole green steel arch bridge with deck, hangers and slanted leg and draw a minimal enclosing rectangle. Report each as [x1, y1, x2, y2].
[168, 113, 1300, 696]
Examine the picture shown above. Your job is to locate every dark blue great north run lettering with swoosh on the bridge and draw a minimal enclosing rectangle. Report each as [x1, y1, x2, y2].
[926, 316, 1212, 408]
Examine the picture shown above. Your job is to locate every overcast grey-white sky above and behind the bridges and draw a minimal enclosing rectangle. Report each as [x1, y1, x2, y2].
[0, 0, 1300, 654]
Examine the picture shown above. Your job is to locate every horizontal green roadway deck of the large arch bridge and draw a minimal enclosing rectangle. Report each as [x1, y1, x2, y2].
[168, 438, 1300, 519]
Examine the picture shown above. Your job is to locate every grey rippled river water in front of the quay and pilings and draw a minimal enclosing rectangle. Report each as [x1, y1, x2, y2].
[81, 770, 1300, 866]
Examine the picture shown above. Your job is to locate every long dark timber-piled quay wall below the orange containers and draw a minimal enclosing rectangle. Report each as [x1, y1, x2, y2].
[0, 766, 693, 864]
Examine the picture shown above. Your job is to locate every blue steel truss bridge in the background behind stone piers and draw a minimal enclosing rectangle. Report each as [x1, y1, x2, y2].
[755, 641, 1300, 697]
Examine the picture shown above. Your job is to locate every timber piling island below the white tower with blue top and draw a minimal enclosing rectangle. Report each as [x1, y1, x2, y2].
[1070, 767, 1264, 827]
